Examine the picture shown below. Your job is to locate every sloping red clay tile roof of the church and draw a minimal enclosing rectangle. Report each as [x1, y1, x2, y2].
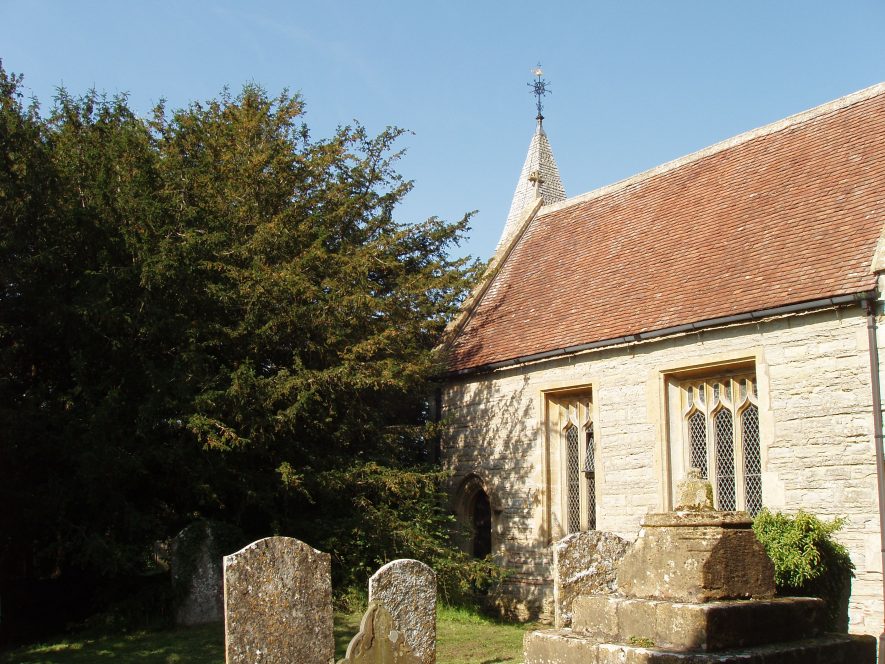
[449, 84, 885, 371]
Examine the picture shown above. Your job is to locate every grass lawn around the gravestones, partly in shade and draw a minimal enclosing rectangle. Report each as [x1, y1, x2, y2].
[0, 607, 531, 664]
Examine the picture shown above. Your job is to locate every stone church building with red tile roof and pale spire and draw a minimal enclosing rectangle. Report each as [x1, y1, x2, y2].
[439, 79, 885, 635]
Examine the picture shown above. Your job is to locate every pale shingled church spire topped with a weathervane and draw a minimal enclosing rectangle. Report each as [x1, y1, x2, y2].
[498, 64, 565, 249]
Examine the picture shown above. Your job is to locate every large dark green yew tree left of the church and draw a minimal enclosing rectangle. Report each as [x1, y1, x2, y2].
[0, 61, 490, 632]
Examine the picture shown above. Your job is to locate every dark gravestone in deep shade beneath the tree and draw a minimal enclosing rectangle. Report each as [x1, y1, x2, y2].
[170, 521, 224, 625]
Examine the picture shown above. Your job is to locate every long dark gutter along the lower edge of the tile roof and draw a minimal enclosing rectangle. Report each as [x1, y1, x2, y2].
[440, 289, 872, 376]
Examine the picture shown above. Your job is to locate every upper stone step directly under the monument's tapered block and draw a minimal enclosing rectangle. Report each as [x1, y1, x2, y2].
[572, 595, 824, 652]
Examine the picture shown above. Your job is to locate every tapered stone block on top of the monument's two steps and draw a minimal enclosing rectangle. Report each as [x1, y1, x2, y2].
[618, 511, 775, 602]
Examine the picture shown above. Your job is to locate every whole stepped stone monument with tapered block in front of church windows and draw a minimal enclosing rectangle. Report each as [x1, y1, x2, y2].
[525, 478, 876, 664]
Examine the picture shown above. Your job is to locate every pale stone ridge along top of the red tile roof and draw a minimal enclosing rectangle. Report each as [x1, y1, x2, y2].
[537, 81, 885, 217]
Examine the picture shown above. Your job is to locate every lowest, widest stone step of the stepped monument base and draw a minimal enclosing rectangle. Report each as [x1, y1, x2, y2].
[524, 629, 876, 664]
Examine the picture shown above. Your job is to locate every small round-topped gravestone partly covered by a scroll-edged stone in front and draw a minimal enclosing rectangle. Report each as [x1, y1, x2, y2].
[369, 559, 436, 664]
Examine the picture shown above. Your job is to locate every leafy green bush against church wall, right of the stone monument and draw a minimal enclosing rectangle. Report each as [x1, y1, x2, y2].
[753, 509, 854, 631]
